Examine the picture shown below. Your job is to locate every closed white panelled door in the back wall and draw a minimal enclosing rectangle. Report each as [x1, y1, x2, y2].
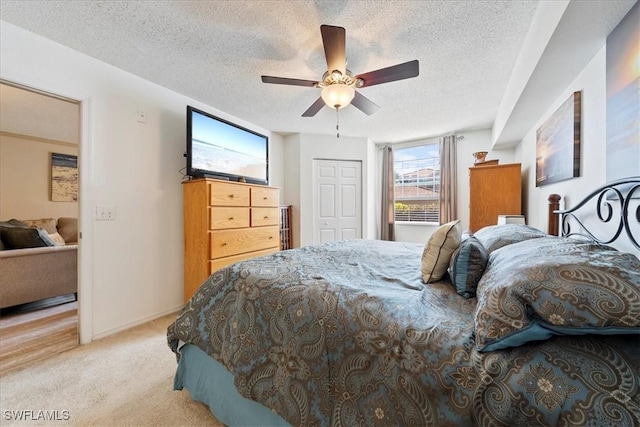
[313, 159, 362, 244]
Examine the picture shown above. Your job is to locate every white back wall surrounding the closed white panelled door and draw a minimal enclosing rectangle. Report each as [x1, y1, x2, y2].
[285, 134, 375, 247]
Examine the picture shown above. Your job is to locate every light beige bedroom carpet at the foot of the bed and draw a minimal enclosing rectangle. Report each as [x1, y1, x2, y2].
[0, 314, 222, 427]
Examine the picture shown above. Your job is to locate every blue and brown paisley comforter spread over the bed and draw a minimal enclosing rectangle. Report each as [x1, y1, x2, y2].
[168, 240, 640, 426]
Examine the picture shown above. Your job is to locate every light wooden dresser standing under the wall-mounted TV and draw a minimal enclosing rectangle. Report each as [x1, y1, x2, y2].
[183, 179, 280, 302]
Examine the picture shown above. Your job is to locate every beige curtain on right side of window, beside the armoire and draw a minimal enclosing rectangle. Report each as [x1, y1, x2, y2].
[440, 135, 458, 224]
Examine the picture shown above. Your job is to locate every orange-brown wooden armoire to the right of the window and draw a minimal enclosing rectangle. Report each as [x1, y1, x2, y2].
[469, 163, 522, 232]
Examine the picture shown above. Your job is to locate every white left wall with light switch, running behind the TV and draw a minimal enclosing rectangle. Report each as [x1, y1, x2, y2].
[0, 21, 286, 343]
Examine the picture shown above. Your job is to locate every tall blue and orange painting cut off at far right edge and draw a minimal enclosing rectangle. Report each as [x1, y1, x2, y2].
[607, 3, 640, 182]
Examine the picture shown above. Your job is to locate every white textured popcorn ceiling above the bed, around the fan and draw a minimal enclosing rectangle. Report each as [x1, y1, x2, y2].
[0, 1, 552, 142]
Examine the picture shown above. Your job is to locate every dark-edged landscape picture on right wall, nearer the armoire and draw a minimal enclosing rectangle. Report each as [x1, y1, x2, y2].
[536, 92, 582, 187]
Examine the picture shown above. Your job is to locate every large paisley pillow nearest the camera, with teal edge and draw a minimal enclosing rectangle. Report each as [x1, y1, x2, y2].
[475, 236, 640, 351]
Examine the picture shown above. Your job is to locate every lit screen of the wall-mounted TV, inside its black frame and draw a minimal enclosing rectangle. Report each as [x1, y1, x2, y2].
[191, 139, 267, 179]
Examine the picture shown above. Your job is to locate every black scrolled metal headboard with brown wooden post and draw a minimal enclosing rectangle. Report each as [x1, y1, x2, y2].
[549, 176, 640, 249]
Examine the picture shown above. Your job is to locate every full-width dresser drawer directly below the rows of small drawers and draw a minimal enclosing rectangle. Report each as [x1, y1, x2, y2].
[209, 226, 280, 259]
